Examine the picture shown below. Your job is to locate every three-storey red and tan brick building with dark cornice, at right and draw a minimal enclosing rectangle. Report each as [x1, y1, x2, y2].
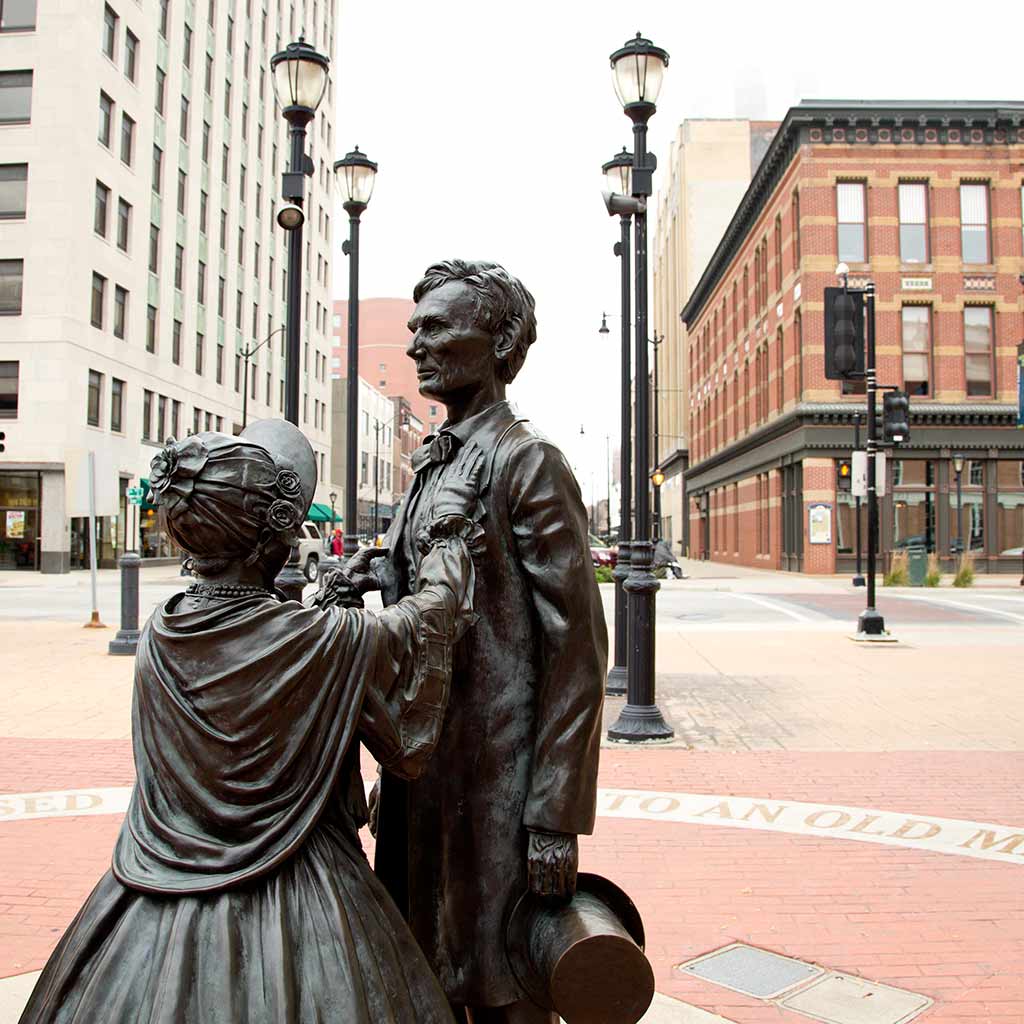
[680, 101, 1024, 572]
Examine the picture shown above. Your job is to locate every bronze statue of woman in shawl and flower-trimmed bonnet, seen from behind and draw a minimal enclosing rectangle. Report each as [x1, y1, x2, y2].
[22, 420, 481, 1024]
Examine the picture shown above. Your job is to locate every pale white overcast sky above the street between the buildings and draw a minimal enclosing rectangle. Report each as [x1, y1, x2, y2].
[334, 0, 1024, 502]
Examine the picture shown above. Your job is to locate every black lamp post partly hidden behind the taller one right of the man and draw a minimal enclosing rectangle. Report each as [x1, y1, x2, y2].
[600, 146, 636, 696]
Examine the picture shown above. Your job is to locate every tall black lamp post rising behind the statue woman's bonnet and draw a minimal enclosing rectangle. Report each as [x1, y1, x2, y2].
[268, 36, 331, 601]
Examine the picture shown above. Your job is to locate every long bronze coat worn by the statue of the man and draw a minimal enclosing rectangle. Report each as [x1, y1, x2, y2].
[376, 401, 607, 1007]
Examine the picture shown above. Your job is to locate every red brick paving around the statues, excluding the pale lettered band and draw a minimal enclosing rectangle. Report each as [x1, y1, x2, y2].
[0, 740, 1024, 1024]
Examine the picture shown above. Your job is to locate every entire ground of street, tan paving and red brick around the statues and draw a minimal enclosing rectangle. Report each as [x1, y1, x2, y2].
[0, 563, 1024, 1024]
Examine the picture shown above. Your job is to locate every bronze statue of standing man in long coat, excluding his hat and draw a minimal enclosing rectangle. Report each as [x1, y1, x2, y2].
[376, 260, 607, 1024]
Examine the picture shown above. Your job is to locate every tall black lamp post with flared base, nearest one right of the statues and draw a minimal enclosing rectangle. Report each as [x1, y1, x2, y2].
[608, 33, 674, 742]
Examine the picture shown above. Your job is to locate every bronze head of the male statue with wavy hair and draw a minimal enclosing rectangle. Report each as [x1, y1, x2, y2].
[408, 260, 537, 402]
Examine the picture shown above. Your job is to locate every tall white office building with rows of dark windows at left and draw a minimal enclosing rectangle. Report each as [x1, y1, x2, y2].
[0, 0, 335, 572]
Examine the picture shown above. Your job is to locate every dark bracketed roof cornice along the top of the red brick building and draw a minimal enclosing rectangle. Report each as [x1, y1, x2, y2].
[679, 99, 1024, 327]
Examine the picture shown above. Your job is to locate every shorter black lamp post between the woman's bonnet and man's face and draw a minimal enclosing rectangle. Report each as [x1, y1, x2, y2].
[334, 146, 377, 555]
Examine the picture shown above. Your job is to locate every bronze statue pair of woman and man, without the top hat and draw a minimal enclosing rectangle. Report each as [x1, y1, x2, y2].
[22, 260, 606, 1024]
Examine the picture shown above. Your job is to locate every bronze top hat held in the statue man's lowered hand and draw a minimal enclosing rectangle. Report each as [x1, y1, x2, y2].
[506, 872, 654, 1024]
